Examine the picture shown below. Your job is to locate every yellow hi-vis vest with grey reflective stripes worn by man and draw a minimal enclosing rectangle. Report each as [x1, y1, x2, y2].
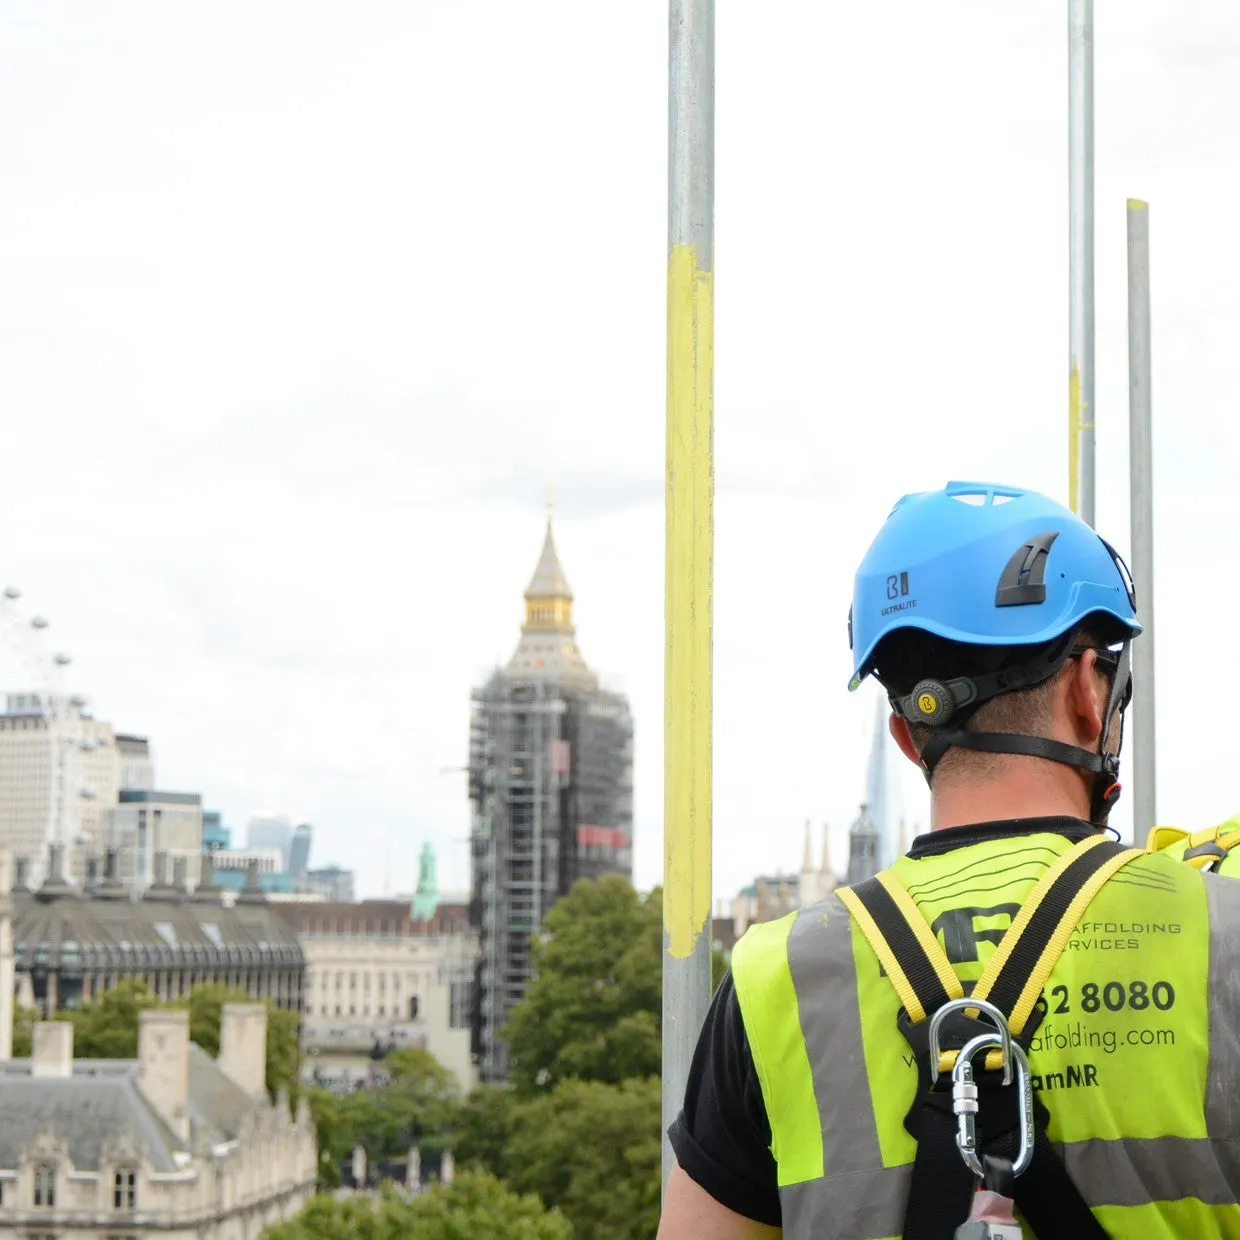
[732, 833, 1240, 1240]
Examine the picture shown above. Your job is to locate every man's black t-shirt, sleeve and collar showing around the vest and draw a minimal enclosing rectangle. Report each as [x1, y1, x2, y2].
[668, 818, 1097, 1226]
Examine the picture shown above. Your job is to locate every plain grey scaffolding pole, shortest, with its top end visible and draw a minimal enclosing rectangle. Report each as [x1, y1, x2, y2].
[1128, 198, 1158, 841]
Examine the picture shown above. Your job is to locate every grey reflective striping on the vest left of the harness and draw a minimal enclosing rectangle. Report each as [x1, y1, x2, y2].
[780, 895, 913, 1240]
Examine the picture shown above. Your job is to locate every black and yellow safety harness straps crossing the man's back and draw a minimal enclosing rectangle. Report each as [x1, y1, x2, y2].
[837, 835, 1146, 1240]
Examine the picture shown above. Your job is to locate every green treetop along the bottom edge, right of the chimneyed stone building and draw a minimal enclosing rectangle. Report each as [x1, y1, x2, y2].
[263, 1172, 573, 1240]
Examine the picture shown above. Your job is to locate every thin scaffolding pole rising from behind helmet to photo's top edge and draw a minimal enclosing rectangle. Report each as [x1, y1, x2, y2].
[1068, 0, 1095, 526]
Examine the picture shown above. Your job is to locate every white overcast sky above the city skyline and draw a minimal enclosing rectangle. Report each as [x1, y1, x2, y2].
[0, 0, 1240, 894]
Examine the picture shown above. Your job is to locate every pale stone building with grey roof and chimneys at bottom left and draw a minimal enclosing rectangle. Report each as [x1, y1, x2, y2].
[0, 1003, 317, 1240]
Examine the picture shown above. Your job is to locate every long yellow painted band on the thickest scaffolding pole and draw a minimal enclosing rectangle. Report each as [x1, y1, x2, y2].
[663, 246, 714, 960]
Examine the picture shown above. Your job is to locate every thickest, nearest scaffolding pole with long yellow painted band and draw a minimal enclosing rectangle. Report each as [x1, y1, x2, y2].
[662, 0, 714, 1188]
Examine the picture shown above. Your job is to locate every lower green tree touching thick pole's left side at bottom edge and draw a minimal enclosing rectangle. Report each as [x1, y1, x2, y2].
[506, 1078, 662, 1240]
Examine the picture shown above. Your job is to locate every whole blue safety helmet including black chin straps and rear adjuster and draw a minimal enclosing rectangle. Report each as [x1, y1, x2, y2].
[848, 482, 1141, 826]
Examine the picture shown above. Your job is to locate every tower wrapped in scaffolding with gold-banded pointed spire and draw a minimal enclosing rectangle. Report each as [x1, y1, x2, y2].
[469, 505, 632, 1081]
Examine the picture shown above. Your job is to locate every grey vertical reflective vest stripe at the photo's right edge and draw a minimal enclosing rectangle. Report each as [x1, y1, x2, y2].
[1202, 874, 1240, 1140]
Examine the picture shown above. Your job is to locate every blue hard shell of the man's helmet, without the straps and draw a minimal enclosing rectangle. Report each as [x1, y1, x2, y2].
[848, 482, 1141, 689]
